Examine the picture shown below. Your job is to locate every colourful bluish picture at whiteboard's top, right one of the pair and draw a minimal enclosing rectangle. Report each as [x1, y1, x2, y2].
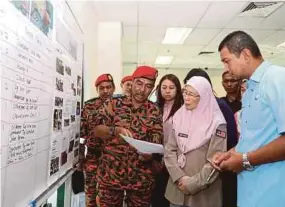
[30, 0, 54, 39]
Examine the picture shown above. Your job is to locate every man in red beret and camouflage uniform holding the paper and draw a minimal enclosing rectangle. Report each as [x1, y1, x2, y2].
[87, 66, 163, 207]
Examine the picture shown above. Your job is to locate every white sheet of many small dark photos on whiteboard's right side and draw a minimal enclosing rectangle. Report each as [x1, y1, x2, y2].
[49, 55, 82, 176]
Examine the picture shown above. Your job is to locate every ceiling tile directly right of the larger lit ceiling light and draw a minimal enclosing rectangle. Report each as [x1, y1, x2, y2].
[184, 28, 220, 45]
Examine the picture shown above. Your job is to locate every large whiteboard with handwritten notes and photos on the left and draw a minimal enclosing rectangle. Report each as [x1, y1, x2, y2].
[0, 0, 82, 207]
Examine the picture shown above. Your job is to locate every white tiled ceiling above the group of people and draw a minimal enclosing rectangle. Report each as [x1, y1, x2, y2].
[93, 0, 285, 73]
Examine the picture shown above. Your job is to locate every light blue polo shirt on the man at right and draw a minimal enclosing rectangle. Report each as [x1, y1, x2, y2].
[236, 61, 285, 207]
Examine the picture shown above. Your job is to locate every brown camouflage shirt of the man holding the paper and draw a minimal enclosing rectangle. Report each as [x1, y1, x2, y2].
[90, 97, 163, 191]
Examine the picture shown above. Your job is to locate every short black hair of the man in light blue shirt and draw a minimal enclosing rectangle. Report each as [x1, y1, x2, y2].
[219, 31, 262, 58]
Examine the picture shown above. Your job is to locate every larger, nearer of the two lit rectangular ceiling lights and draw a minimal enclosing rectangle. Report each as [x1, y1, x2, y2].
[162, 27, 193, 45]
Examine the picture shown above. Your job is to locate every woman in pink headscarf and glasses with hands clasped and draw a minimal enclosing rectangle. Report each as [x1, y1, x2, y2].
[164, 77, 227, 207]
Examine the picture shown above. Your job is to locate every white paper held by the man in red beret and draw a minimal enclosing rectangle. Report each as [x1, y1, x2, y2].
[120, 134, 164, 154]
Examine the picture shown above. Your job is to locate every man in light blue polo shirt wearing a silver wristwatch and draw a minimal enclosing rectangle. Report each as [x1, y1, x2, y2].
[213, 31, 285, 207]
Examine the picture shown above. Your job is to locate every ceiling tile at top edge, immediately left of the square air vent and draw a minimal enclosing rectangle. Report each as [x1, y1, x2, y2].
[197, 1, 248, 28]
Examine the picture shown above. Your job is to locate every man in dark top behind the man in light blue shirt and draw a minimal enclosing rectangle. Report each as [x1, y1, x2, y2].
[221, 71, 241, 113]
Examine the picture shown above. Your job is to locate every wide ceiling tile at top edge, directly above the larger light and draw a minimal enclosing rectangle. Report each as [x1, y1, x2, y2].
[139, 1, 210, 27]
